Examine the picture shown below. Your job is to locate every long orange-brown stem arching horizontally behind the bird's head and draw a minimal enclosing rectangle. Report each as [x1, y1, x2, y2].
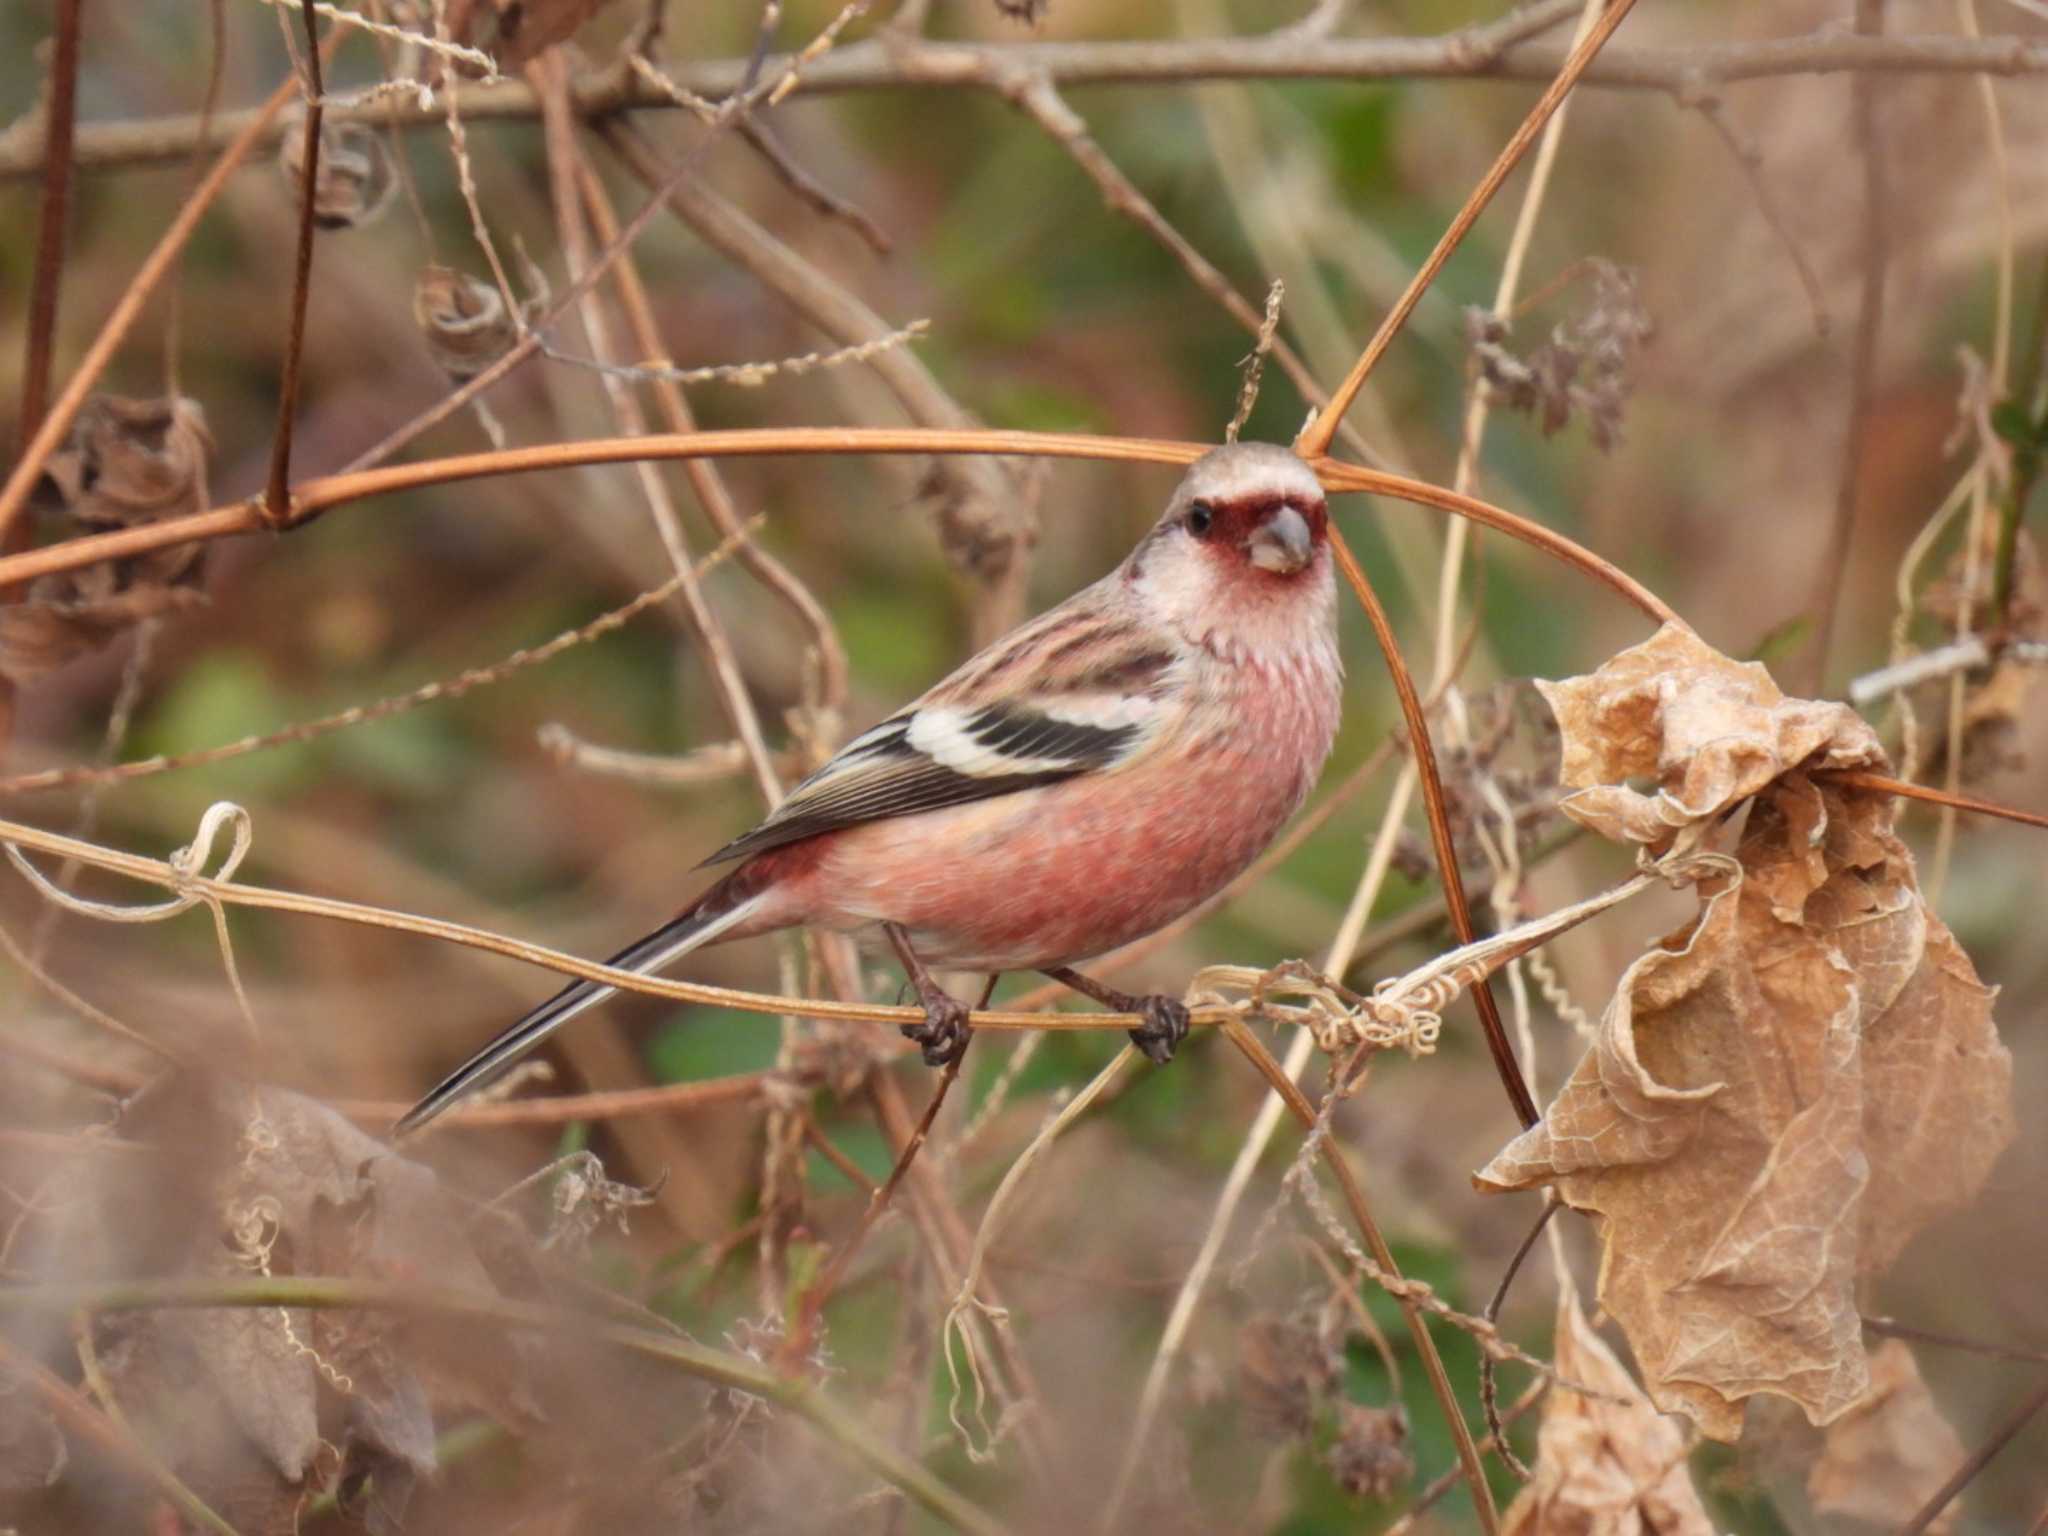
[0, 426, 1677, 623]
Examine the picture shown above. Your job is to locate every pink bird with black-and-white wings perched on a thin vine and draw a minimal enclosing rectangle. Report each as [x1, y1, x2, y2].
[397, 442, 1343, 1133]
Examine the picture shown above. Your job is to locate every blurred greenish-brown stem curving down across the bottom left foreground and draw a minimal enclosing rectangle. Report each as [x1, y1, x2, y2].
[0, 1276, 1004, 1536]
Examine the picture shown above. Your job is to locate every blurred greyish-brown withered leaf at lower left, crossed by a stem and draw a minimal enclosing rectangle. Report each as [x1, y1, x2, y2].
[79, 1083, 522, 1530]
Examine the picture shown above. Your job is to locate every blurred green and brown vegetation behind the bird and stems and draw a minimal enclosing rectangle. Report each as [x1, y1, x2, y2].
[0, 0, 2048, 1536]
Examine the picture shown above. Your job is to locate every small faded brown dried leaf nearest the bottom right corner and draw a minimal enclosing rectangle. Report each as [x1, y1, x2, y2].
[1806, 1339, 1966, 1536]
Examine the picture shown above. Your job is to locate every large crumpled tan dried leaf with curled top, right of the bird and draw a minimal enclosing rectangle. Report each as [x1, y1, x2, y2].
[1479, 631, 2013, 1440]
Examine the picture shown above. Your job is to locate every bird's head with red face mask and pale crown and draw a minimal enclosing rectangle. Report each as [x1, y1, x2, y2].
[1124, 442, 1333, 651]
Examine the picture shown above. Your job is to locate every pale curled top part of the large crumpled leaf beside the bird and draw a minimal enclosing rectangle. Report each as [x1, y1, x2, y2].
[1536, 623, 1884, 844]
